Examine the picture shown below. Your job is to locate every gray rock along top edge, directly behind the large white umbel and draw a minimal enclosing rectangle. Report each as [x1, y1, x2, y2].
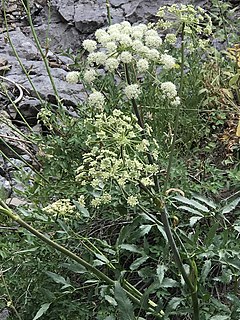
[21, 0, 207, 52]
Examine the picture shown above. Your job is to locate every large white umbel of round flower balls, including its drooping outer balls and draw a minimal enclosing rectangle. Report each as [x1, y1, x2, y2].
[67, 21, 179, 111]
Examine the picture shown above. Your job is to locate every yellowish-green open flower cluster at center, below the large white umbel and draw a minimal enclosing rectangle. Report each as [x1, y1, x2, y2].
[76, 109, 158, 206]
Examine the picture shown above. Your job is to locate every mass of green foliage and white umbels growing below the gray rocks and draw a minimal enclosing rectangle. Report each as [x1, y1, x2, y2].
[0, 1, 240, 320]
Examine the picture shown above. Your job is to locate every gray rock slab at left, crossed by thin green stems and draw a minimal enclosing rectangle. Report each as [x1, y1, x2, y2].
[0, 29, 86, 105]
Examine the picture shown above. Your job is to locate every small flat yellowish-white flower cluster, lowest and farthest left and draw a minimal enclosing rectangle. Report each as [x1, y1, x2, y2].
[43, 199, 75, 217]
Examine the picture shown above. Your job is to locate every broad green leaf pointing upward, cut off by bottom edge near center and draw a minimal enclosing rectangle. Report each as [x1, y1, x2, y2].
[114, 281, 135, 320]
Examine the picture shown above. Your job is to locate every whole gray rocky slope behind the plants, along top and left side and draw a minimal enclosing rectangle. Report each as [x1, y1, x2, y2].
[0, 0, 237, 205]
